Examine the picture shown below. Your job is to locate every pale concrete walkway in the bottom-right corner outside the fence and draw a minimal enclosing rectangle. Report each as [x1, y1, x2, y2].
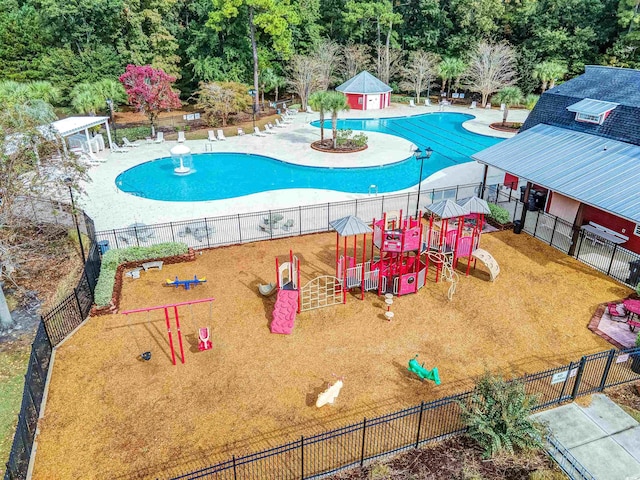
[533, 394, 640, 480]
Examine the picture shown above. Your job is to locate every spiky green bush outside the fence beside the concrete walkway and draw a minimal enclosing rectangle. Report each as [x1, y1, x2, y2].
[458, 373, 543, 458]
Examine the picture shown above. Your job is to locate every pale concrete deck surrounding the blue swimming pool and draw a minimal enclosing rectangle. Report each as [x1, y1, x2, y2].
[80, 104, 529, 230]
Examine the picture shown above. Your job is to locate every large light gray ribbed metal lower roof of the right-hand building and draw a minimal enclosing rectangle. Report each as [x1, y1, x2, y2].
[472, 124, 640, 223]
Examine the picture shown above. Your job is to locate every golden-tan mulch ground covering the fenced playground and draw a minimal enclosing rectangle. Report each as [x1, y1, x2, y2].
[33, 231, 629, 479]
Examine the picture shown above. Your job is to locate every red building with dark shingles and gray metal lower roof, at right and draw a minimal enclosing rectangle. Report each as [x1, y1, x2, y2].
[472, 66, 640, 253]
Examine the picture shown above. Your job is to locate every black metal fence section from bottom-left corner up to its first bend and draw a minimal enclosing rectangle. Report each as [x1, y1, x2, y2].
[4, 322, 52, 480]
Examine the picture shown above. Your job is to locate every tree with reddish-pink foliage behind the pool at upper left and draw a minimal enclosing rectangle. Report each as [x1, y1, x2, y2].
[120, 65, 182, 135]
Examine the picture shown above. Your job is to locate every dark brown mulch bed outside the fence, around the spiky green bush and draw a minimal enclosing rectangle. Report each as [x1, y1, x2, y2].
[330, 436, 566, 480]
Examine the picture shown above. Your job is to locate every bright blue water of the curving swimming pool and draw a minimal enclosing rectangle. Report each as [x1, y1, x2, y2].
[116, 113, 500, 202]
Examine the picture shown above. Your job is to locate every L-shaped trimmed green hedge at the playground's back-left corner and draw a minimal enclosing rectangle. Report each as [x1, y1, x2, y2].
[94, 242, 189, 307]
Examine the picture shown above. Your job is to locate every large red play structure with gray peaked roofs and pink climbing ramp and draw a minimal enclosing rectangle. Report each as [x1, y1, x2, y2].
[258, 197, 500, 334]
